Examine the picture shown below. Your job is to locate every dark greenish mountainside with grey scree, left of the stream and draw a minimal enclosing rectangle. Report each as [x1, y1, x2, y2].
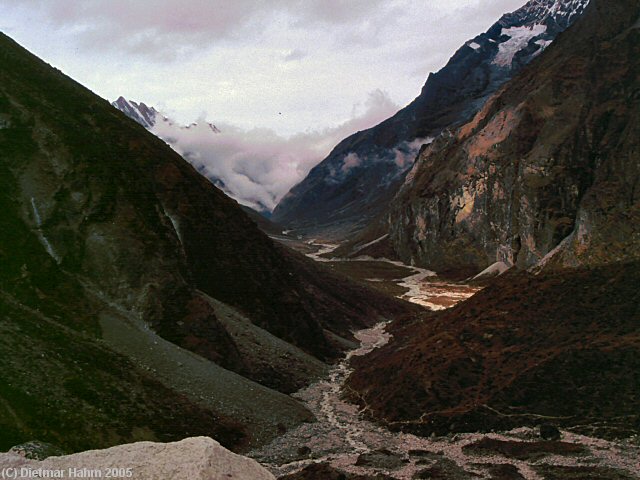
[0, 31, 407, 451]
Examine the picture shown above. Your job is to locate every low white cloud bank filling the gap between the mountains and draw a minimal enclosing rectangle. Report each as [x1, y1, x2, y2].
[153, 90, 398, 210]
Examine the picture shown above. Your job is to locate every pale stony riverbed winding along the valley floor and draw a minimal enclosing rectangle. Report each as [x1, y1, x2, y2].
[254, 238, 640, 480]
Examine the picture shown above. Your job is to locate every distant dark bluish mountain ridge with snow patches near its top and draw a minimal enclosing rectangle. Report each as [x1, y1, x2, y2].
[273, 0, 588, 239]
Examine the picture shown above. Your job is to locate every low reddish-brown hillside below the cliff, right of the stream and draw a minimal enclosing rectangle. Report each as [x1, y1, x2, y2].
[348, 261, 640, 438]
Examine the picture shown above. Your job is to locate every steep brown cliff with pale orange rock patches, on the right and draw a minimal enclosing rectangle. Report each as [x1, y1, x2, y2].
[385, 1, 640, 269]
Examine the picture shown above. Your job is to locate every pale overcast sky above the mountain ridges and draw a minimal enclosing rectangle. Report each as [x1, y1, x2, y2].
[0, 0, 525, 136]
